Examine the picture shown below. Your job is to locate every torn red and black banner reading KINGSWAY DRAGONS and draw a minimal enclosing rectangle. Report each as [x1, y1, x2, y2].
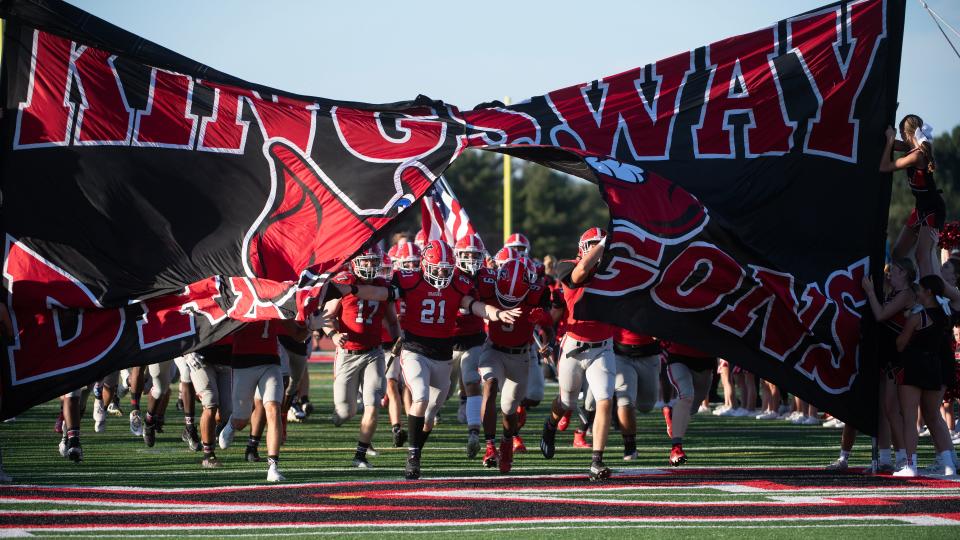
[0, 0, 904, 432]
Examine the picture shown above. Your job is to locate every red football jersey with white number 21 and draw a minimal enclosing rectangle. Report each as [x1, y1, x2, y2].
[393, 270, 473, 338]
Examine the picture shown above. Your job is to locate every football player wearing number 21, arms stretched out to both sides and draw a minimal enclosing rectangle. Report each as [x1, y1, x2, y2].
[335, 240, 520, 480]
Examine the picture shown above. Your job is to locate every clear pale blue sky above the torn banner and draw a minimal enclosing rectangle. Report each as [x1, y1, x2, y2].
[70, 0, 960, 133]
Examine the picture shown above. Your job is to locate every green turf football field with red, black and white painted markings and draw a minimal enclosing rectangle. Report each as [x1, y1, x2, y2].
[0, 364, 960, 538]
